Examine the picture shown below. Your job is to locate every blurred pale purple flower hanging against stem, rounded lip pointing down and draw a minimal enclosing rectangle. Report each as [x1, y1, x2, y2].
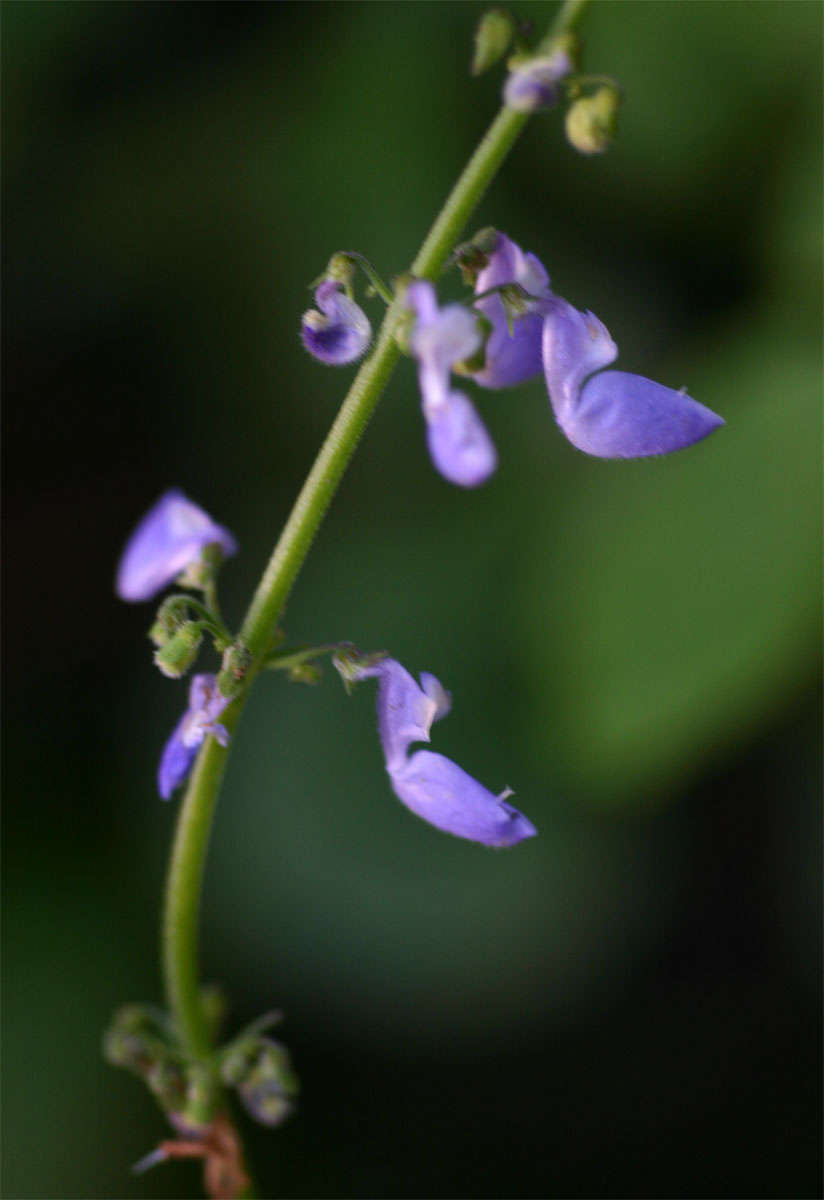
[407, 280, 498, 487]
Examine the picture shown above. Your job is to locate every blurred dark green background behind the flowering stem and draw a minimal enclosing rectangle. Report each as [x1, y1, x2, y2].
[2, 2, 822, 1198]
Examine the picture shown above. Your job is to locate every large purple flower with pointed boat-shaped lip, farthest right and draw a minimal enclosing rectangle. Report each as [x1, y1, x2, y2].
[543, 296, 724, 458]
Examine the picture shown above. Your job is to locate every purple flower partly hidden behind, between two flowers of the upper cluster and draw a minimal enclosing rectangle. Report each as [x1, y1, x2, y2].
[473, 233, 552, 388]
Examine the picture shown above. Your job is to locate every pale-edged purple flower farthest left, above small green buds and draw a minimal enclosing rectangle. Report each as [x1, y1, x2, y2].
[116, 487, 237, 600]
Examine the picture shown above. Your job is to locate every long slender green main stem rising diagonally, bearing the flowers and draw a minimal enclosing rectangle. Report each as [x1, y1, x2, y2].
[163, 0, 588, 1171]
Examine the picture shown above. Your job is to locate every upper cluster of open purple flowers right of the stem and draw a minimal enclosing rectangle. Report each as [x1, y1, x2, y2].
[301, 233, 723, 487]
